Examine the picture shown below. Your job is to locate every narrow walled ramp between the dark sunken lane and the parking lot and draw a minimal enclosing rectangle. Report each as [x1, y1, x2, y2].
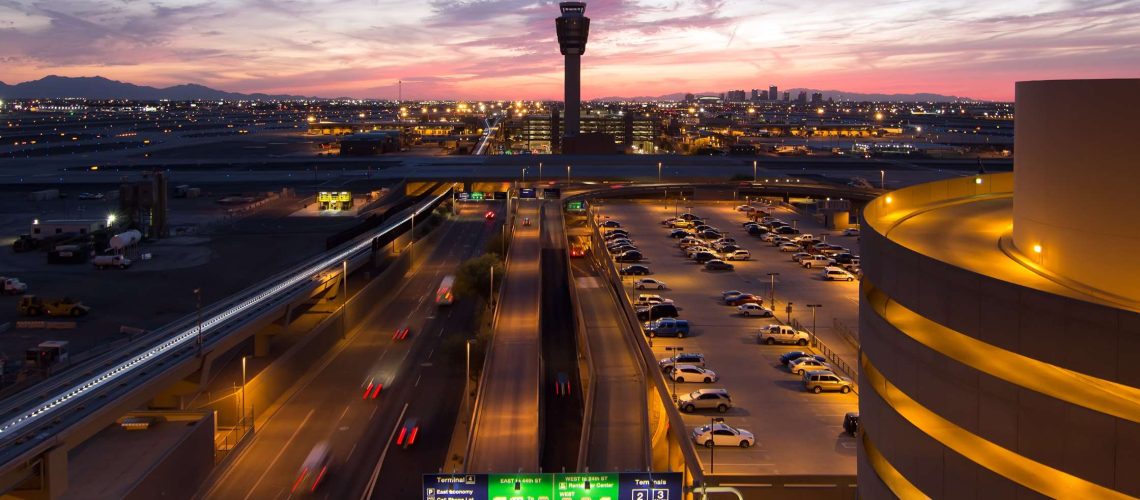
[571, 259, 648, 472]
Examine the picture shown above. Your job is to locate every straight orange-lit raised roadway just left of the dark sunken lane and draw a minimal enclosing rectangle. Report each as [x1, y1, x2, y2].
[466, 200, 542, 473]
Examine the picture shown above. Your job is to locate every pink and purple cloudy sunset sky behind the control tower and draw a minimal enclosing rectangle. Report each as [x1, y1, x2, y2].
[0, 0, 1140, 100]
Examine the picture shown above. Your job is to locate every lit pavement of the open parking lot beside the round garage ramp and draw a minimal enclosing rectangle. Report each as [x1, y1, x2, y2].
[602, 202, 858, 474]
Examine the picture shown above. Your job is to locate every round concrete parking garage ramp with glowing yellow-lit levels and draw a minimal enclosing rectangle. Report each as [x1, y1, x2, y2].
[857, 80, 1140, 499]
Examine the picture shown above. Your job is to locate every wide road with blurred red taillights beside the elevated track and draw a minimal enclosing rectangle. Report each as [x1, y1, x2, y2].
[201, 205, 496, 499]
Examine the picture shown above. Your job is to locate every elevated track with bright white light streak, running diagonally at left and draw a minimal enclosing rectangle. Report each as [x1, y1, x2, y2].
[0, 188, 451, 497]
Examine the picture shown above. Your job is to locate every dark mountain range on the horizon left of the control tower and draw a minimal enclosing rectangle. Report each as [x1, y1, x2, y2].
[0, 75, 306, 100]
